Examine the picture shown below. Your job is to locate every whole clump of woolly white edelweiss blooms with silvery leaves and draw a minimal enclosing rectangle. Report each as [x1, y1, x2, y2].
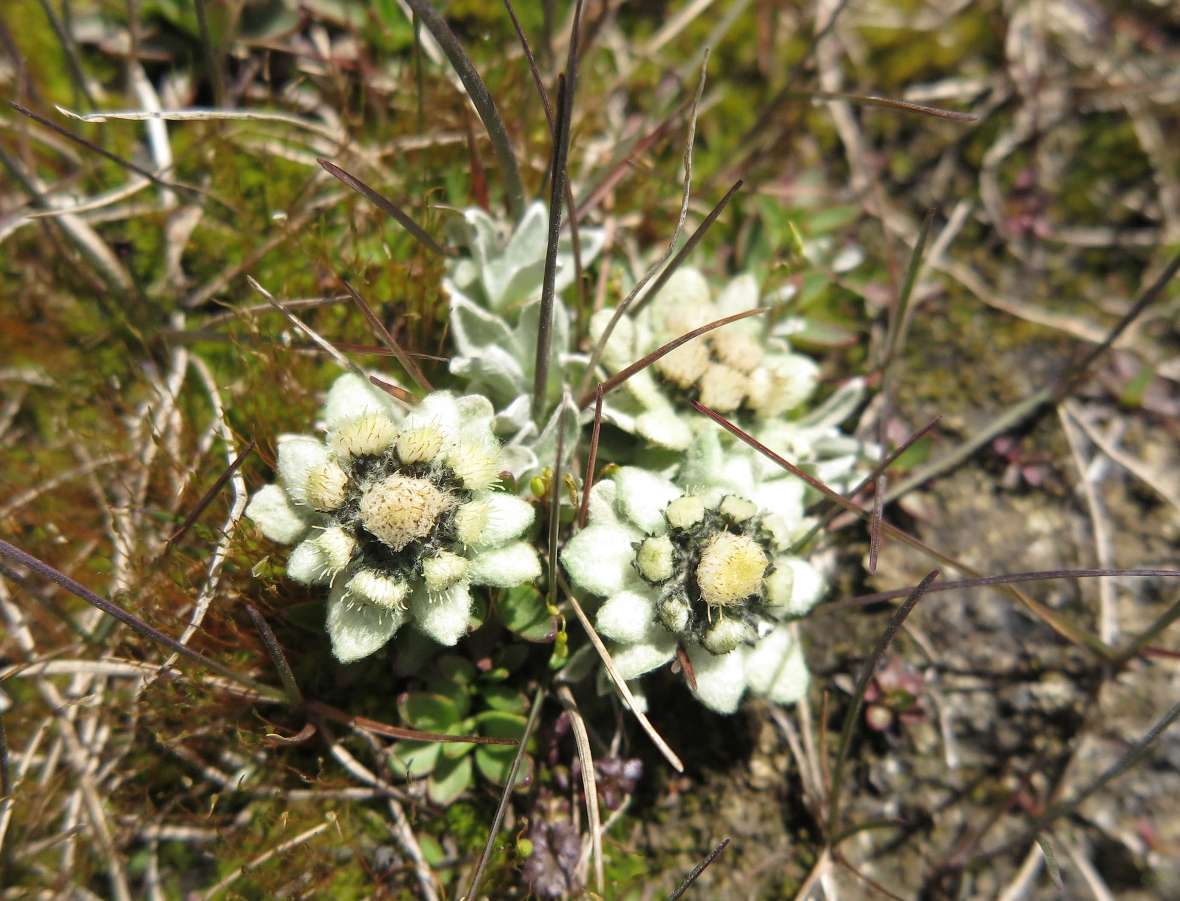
[247, 204, 864, 712]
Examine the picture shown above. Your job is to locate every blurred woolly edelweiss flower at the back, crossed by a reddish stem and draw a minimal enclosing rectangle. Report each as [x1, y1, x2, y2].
[590, 269, 819, 451]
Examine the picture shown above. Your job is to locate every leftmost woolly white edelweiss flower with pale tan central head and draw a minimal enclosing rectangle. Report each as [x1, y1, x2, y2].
[245, 374, 540, 663]
